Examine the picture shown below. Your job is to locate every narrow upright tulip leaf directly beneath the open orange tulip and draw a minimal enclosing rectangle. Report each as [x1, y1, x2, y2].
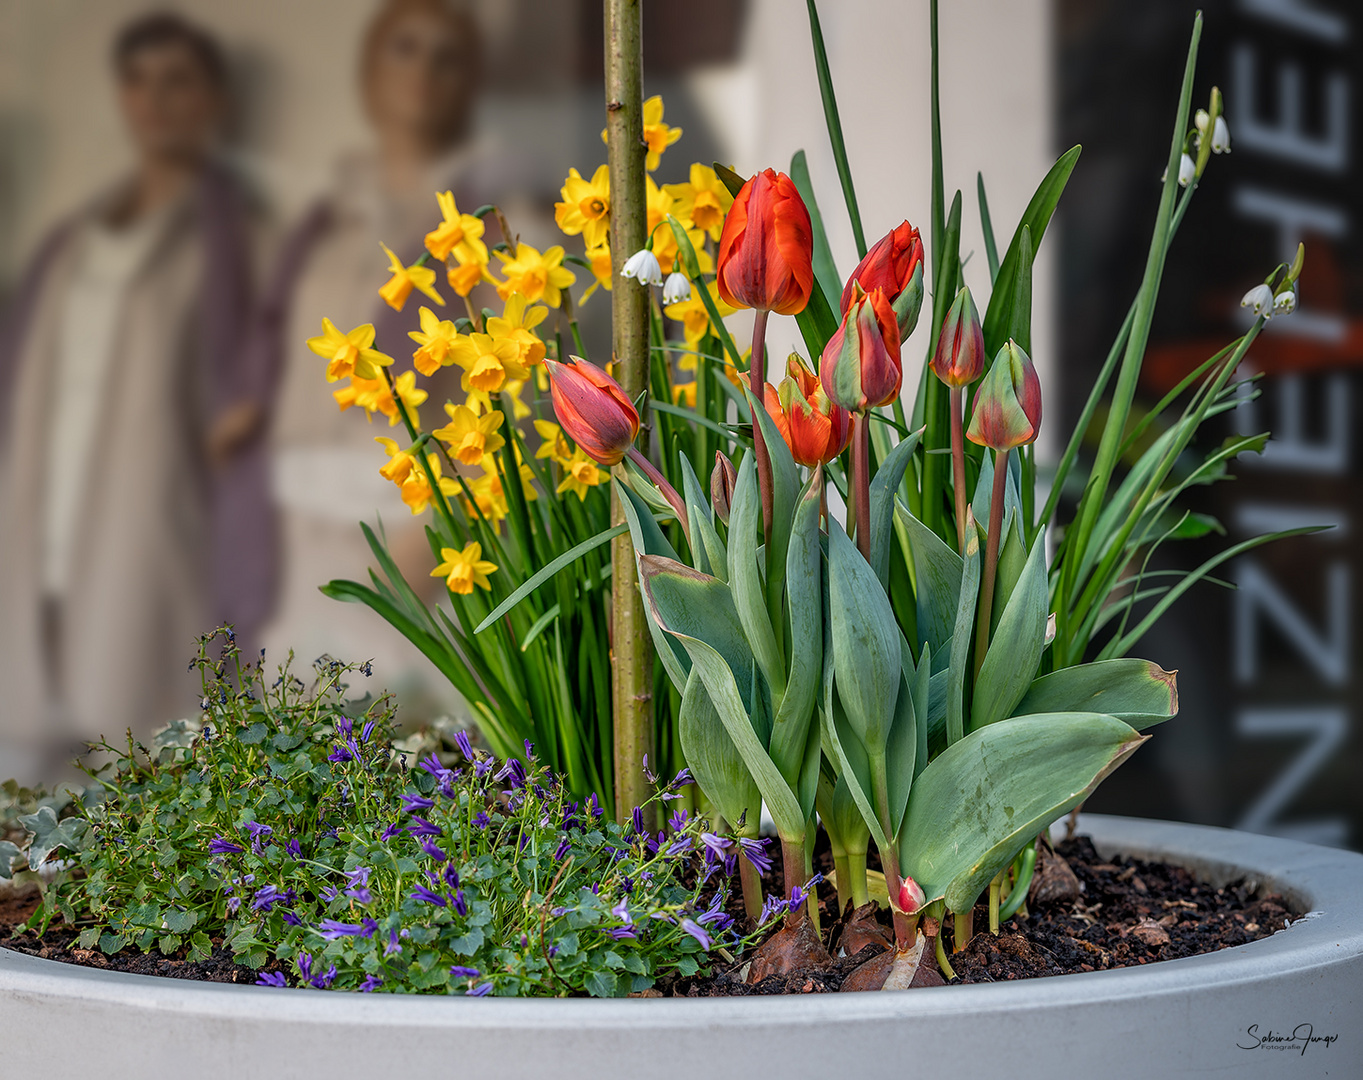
[769, 469, 823, 785]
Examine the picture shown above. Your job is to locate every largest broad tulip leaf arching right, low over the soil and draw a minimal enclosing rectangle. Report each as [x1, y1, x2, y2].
[900, 712, 1149, 911]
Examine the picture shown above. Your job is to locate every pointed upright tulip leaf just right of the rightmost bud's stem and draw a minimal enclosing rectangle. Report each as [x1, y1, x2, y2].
[970, 530, 1050, 731]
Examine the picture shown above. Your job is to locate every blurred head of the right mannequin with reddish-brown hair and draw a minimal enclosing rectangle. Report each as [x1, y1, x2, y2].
[360, 0, 481, 158]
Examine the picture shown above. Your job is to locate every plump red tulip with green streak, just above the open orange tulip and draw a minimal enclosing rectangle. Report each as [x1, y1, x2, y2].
[819, 282, 904, 413]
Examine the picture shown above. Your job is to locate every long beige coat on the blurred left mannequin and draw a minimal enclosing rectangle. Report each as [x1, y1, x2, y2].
[0, 193, 207, 749]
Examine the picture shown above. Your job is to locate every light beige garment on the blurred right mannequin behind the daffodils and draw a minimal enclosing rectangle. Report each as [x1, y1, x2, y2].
[262, 147, 466, 717]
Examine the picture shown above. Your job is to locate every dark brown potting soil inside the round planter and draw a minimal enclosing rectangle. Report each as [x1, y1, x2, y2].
[0, 835, 1300, 997]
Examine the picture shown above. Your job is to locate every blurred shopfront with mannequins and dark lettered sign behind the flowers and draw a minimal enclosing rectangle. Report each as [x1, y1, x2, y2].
[0, 0, 1363, 845]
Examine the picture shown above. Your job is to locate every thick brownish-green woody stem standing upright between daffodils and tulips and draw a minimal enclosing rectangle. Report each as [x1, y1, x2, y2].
[605, 0, 654, 826]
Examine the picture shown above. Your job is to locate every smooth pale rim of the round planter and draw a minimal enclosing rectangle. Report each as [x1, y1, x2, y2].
[0, 814, 1363, 1031]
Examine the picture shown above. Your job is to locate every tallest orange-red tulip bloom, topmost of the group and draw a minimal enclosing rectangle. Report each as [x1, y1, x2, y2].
[717, 169, 814, 315]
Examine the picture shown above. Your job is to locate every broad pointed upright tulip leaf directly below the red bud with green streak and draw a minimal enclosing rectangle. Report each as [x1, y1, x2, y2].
[829, 520, 904, 765]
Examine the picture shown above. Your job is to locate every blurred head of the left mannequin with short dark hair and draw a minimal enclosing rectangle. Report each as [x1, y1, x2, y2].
[113, 14, 226, 166]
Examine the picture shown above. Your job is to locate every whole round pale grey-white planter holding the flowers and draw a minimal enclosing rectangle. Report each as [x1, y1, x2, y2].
[0, 815, 1363, 1080]
